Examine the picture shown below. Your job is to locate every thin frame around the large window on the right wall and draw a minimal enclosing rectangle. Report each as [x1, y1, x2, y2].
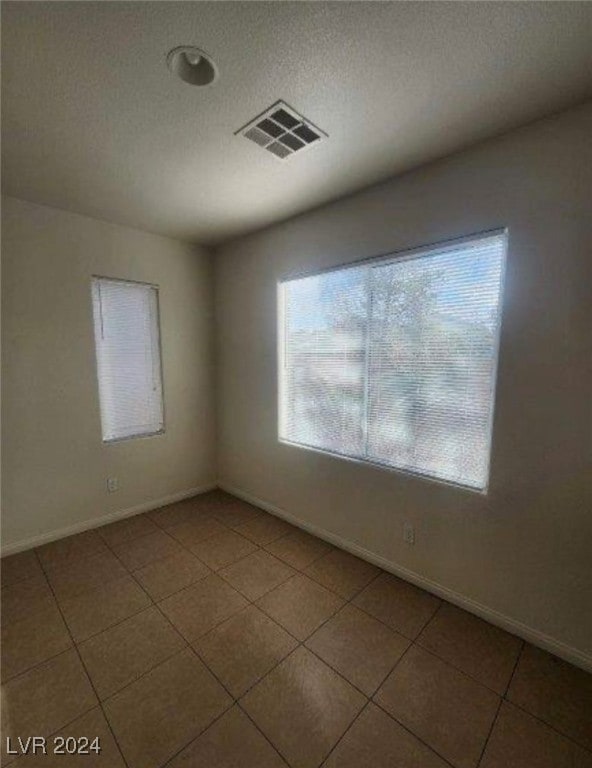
[276, 226, 510, 496]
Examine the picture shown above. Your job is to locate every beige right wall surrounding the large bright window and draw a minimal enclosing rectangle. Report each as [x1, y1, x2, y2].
[215, 105, 592, 663]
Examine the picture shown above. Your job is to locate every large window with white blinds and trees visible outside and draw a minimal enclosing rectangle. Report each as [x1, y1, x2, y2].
[279, 232, 506, 490]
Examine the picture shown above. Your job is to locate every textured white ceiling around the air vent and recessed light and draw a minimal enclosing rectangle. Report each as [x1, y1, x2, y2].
[2, 2, 592, 243]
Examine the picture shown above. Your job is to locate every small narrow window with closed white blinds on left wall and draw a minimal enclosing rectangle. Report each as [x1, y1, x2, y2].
[92, 277, 164, 442]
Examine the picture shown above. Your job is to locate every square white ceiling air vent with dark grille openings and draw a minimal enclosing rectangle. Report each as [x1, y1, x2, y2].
[235, 101, 327, 160]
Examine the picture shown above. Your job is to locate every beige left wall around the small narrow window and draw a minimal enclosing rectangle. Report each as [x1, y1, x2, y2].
[2, 198, 215, 551]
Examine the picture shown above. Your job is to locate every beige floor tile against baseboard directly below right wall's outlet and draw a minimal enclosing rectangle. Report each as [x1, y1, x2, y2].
[353, 573, 442, 640]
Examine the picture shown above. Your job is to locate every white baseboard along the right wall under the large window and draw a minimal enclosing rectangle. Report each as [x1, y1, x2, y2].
[218, 481, 592, 672]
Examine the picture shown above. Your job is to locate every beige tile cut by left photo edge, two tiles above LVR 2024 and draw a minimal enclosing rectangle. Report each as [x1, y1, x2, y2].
[2, 601, 72, 680]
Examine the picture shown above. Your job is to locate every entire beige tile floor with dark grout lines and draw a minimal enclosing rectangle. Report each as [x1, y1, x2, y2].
[1, 491, 592, 768]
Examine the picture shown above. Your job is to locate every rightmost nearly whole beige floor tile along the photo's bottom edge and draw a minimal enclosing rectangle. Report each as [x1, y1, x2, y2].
[374, 645, 500, 768]
